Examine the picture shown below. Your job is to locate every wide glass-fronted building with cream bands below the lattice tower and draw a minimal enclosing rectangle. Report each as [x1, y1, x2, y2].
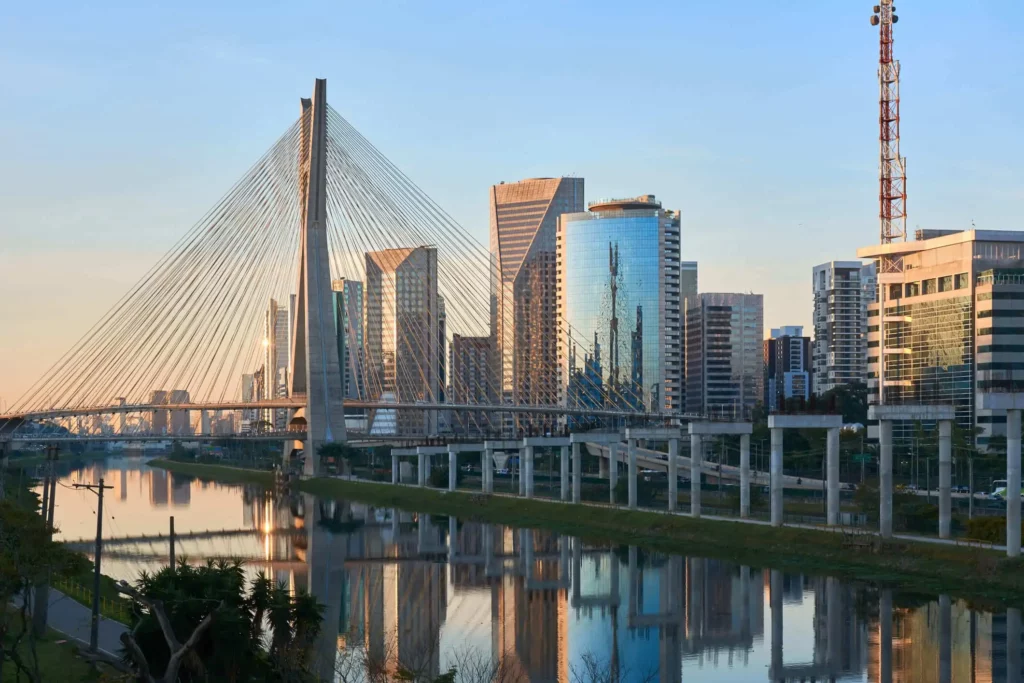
[857, 230, 1024, 446]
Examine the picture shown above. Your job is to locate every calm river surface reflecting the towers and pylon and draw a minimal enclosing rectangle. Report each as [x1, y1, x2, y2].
[29, 459, 1022, 683]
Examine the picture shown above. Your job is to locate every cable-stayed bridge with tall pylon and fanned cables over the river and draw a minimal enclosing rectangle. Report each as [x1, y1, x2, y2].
[0, 80, 704, 467]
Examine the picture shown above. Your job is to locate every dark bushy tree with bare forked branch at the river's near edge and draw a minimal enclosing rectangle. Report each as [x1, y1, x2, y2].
[119, 561, 323, 683]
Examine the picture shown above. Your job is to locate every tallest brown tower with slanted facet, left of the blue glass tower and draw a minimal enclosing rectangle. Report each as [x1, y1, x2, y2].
[490, 178, 584, 430]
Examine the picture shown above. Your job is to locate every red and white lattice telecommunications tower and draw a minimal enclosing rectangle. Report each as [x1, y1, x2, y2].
[871, 0, 906, 245]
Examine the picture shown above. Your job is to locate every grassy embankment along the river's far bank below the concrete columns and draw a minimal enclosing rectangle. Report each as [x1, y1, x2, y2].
[151, 461, 1024, 602]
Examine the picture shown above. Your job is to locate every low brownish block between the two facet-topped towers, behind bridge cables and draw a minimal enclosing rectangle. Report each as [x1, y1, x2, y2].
[447, 334, 498, 434]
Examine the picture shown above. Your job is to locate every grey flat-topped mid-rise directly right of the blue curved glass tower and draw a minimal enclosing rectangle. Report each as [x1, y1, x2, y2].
[686, 293, 764, 419]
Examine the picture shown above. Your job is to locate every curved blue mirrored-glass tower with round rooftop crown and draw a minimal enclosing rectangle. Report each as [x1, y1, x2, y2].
[557, 195, 683, 412]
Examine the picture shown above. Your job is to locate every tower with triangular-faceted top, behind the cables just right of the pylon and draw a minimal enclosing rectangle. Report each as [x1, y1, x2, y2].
[365, 247, 440, 434]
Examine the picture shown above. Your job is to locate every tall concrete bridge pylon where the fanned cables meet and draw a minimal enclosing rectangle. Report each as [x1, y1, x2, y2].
[289, 79, 345, 475]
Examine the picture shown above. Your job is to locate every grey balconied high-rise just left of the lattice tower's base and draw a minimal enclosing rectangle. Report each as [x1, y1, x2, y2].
[811, 261, 876, 396]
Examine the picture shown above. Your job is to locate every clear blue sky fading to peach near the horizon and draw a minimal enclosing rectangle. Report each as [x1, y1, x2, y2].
[0, 0, 1024, 410]
